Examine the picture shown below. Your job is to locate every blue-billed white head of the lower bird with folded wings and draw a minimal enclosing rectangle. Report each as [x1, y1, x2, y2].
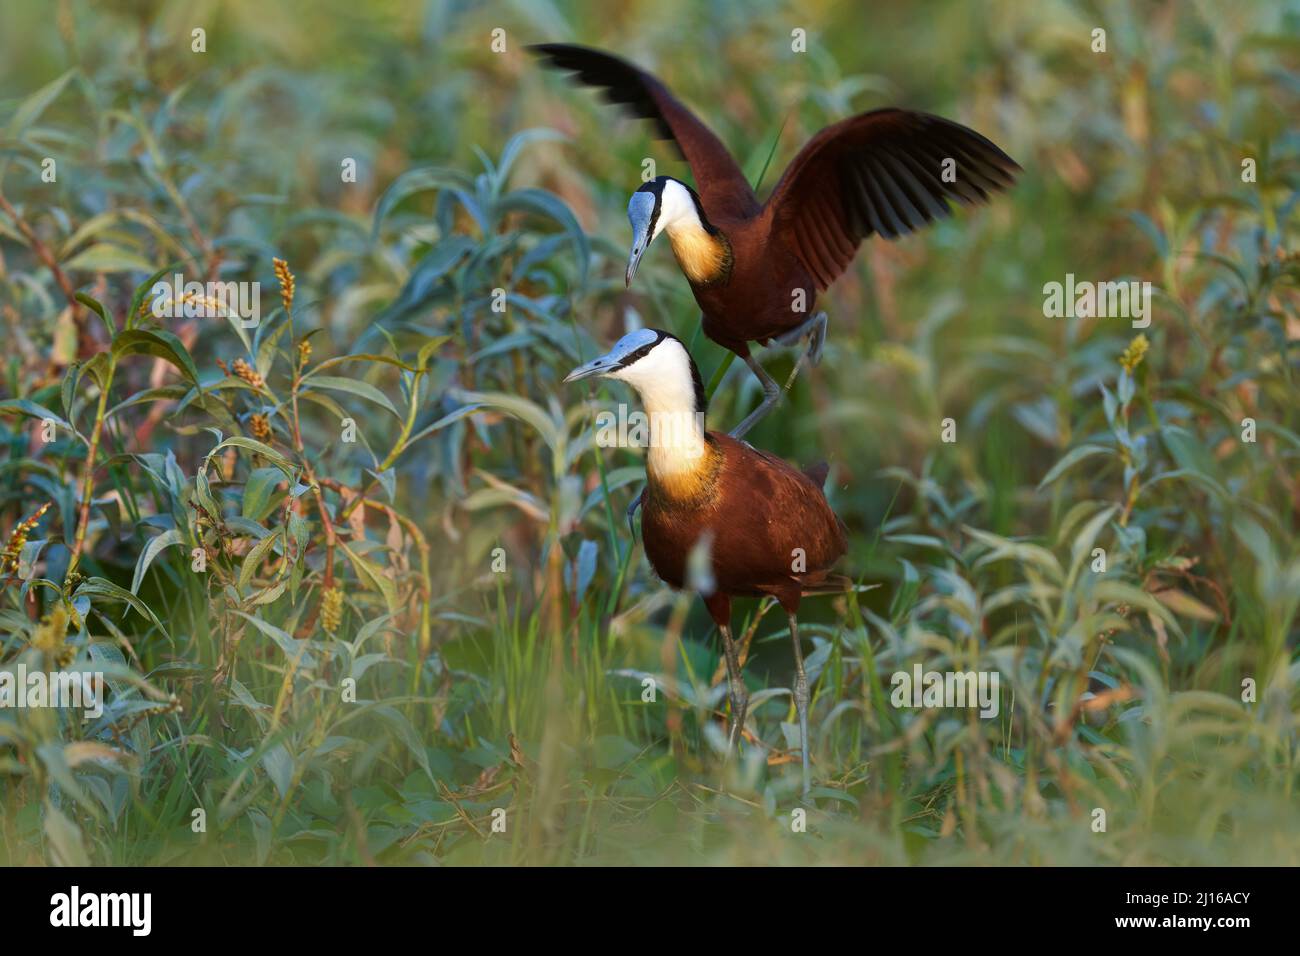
[564, 329, 707, 415]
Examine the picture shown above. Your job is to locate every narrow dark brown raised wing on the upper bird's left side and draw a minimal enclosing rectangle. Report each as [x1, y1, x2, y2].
[528, 43, 761, 217]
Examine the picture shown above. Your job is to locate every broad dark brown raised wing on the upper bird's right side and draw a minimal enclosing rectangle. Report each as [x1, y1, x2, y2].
[764, 109, 1021, 290]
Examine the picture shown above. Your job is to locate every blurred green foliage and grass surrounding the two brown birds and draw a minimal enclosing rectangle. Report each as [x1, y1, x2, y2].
[0, 0, 1300, 864]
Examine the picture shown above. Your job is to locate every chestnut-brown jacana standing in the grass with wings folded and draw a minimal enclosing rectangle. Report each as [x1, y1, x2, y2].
[564, 329, 852, 796]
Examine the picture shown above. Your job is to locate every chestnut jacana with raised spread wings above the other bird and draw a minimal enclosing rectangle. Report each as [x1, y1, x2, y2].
[529, 43, 1021, 437]
